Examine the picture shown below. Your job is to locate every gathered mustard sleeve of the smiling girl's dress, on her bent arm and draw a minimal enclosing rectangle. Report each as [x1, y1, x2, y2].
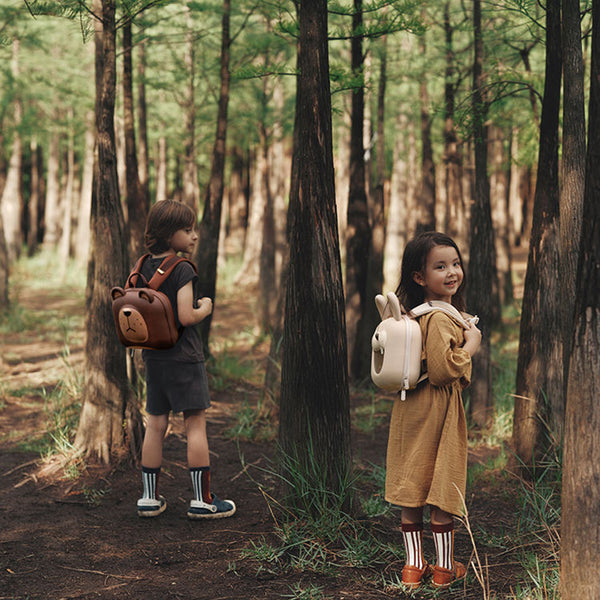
[425, 312, 471, 387]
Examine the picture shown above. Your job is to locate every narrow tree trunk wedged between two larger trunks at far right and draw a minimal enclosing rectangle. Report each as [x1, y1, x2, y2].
[560, 0, 585, 385]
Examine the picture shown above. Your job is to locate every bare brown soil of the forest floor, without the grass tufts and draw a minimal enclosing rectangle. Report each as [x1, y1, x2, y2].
[0, 284, 525, 600]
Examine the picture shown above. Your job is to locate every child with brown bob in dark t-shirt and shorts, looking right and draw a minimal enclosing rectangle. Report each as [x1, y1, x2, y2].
[137, 200, 235, 519]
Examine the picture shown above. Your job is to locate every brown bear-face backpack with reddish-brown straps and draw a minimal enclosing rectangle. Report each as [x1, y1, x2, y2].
[110, 254, 196, 350]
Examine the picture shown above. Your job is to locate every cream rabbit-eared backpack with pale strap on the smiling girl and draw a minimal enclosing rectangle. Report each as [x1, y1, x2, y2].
[371, 292, 478, 400]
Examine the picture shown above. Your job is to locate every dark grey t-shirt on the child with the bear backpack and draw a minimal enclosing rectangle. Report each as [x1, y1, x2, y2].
[137, 256, 204, 363]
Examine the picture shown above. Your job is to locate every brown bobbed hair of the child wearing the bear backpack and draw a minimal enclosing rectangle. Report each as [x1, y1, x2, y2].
[144, 200, 197, 254]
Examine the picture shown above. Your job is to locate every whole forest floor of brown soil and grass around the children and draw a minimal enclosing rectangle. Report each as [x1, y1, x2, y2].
[0, 254, 553, 600]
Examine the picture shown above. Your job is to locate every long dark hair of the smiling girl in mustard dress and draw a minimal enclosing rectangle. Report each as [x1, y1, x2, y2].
[396, 231, 467, 311]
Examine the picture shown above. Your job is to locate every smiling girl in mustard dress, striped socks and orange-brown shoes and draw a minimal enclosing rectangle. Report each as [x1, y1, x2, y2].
[385, 232, 481, 589]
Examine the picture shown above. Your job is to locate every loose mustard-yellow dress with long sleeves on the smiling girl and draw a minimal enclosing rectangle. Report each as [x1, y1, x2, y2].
[385, 311, 471, 515]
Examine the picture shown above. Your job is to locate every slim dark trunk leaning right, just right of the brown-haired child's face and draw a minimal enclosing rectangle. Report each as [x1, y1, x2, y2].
[194, 0, 231, 356]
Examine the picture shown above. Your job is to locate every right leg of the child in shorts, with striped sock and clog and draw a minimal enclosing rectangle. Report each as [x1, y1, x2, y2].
[184, 410, 235, 519]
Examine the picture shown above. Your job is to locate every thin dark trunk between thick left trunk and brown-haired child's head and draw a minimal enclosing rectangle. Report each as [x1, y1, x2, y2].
[123, 18, 149, 261]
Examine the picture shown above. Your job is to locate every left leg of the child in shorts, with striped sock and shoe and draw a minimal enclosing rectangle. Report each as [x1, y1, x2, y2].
[137, 415, 169, 517]
